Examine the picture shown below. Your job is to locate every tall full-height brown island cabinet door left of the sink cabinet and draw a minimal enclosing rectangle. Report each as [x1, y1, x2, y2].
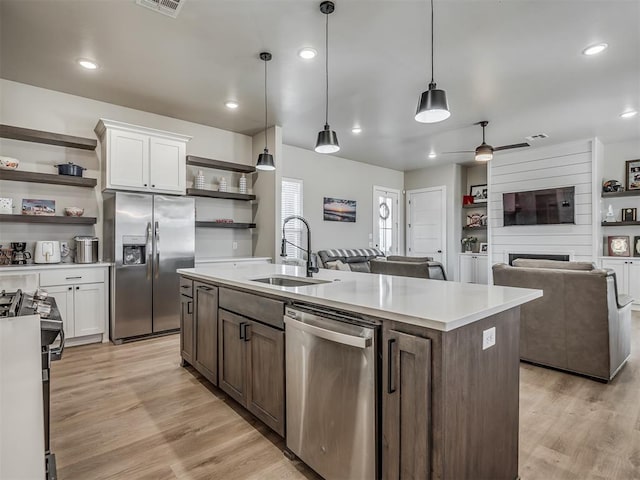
[193, 282, 218, 385]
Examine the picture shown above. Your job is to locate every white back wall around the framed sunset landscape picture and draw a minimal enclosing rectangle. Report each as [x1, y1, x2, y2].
[278, 145, 404, 251]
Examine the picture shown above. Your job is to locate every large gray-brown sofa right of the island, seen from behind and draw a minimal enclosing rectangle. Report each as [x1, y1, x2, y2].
[493, 259, 632, 381]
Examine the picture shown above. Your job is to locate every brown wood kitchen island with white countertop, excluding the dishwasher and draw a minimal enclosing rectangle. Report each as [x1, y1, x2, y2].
[178, 265, 542, 480]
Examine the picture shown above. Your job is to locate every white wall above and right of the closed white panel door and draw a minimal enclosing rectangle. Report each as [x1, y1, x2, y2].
[404, 165, 462, 280]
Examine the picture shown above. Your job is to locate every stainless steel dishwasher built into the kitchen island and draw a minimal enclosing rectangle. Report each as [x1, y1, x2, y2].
[284, 305, 380, 480]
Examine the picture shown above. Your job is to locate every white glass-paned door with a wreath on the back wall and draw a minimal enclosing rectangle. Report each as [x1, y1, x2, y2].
[373, 187, 400, 255]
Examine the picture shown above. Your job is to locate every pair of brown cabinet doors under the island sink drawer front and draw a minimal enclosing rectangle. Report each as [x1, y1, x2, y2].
[218, 309, 285, 436]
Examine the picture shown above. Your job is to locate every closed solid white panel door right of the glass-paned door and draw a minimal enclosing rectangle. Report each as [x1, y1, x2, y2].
[407, 185, 447, 271]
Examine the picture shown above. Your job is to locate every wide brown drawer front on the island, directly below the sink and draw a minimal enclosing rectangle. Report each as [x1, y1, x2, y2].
[218, 288, 284, 329]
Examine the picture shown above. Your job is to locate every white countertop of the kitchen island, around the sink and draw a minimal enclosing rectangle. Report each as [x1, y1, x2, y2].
[178, 264, 542, 331]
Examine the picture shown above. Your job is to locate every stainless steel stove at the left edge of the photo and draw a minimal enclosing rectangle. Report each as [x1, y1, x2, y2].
[0, 289, 64, 480]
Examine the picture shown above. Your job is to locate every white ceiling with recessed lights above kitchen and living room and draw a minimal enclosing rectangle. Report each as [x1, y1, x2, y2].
[0, 0, 640, 170]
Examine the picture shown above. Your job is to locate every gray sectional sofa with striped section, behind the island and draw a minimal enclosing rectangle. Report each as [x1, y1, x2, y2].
[317, 248, 447, 280]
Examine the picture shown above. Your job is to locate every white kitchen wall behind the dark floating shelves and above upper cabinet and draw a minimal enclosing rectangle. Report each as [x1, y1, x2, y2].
[0, 79, 254, 257]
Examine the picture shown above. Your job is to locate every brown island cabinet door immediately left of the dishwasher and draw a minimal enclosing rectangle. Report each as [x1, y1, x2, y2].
[245, 322, 284, 437]
